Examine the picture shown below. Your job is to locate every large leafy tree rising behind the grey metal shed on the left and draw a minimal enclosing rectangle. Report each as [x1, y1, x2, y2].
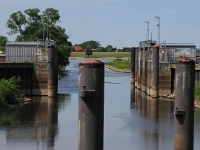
[7, 8, 72, 65]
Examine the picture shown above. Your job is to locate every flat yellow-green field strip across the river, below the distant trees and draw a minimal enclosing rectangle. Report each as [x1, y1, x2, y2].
[70, 52, 130, 58]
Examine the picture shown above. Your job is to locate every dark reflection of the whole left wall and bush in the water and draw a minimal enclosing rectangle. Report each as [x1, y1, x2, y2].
[0, 96, 58, 149]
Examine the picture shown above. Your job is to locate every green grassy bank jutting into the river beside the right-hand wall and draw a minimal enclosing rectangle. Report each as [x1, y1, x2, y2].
[105, 59, 131, 69]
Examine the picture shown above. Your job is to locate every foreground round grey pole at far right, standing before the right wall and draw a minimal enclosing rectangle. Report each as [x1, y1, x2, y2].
[174, 58, 195, 150]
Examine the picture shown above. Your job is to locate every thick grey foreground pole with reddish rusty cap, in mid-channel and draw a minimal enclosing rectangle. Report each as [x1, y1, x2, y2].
[78, 59, 104, 150]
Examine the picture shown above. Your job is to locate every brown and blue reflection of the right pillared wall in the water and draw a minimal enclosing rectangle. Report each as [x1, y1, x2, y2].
[130, 84, 173, 150]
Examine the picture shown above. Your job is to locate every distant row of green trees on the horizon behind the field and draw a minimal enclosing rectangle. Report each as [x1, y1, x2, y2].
[73, 40, 130, 52]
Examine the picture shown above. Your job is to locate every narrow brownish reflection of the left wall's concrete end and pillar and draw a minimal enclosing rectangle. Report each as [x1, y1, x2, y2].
[34, 96, 58, 147]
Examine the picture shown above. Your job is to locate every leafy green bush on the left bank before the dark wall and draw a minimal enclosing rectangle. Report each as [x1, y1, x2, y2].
[0, 77, 20, 106]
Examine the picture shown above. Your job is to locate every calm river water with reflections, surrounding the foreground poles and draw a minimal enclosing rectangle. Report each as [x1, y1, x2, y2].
[0, 59, 200, 150]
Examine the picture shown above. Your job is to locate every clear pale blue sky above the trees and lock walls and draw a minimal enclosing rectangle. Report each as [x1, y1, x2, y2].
[0, 0, 200, 49]
